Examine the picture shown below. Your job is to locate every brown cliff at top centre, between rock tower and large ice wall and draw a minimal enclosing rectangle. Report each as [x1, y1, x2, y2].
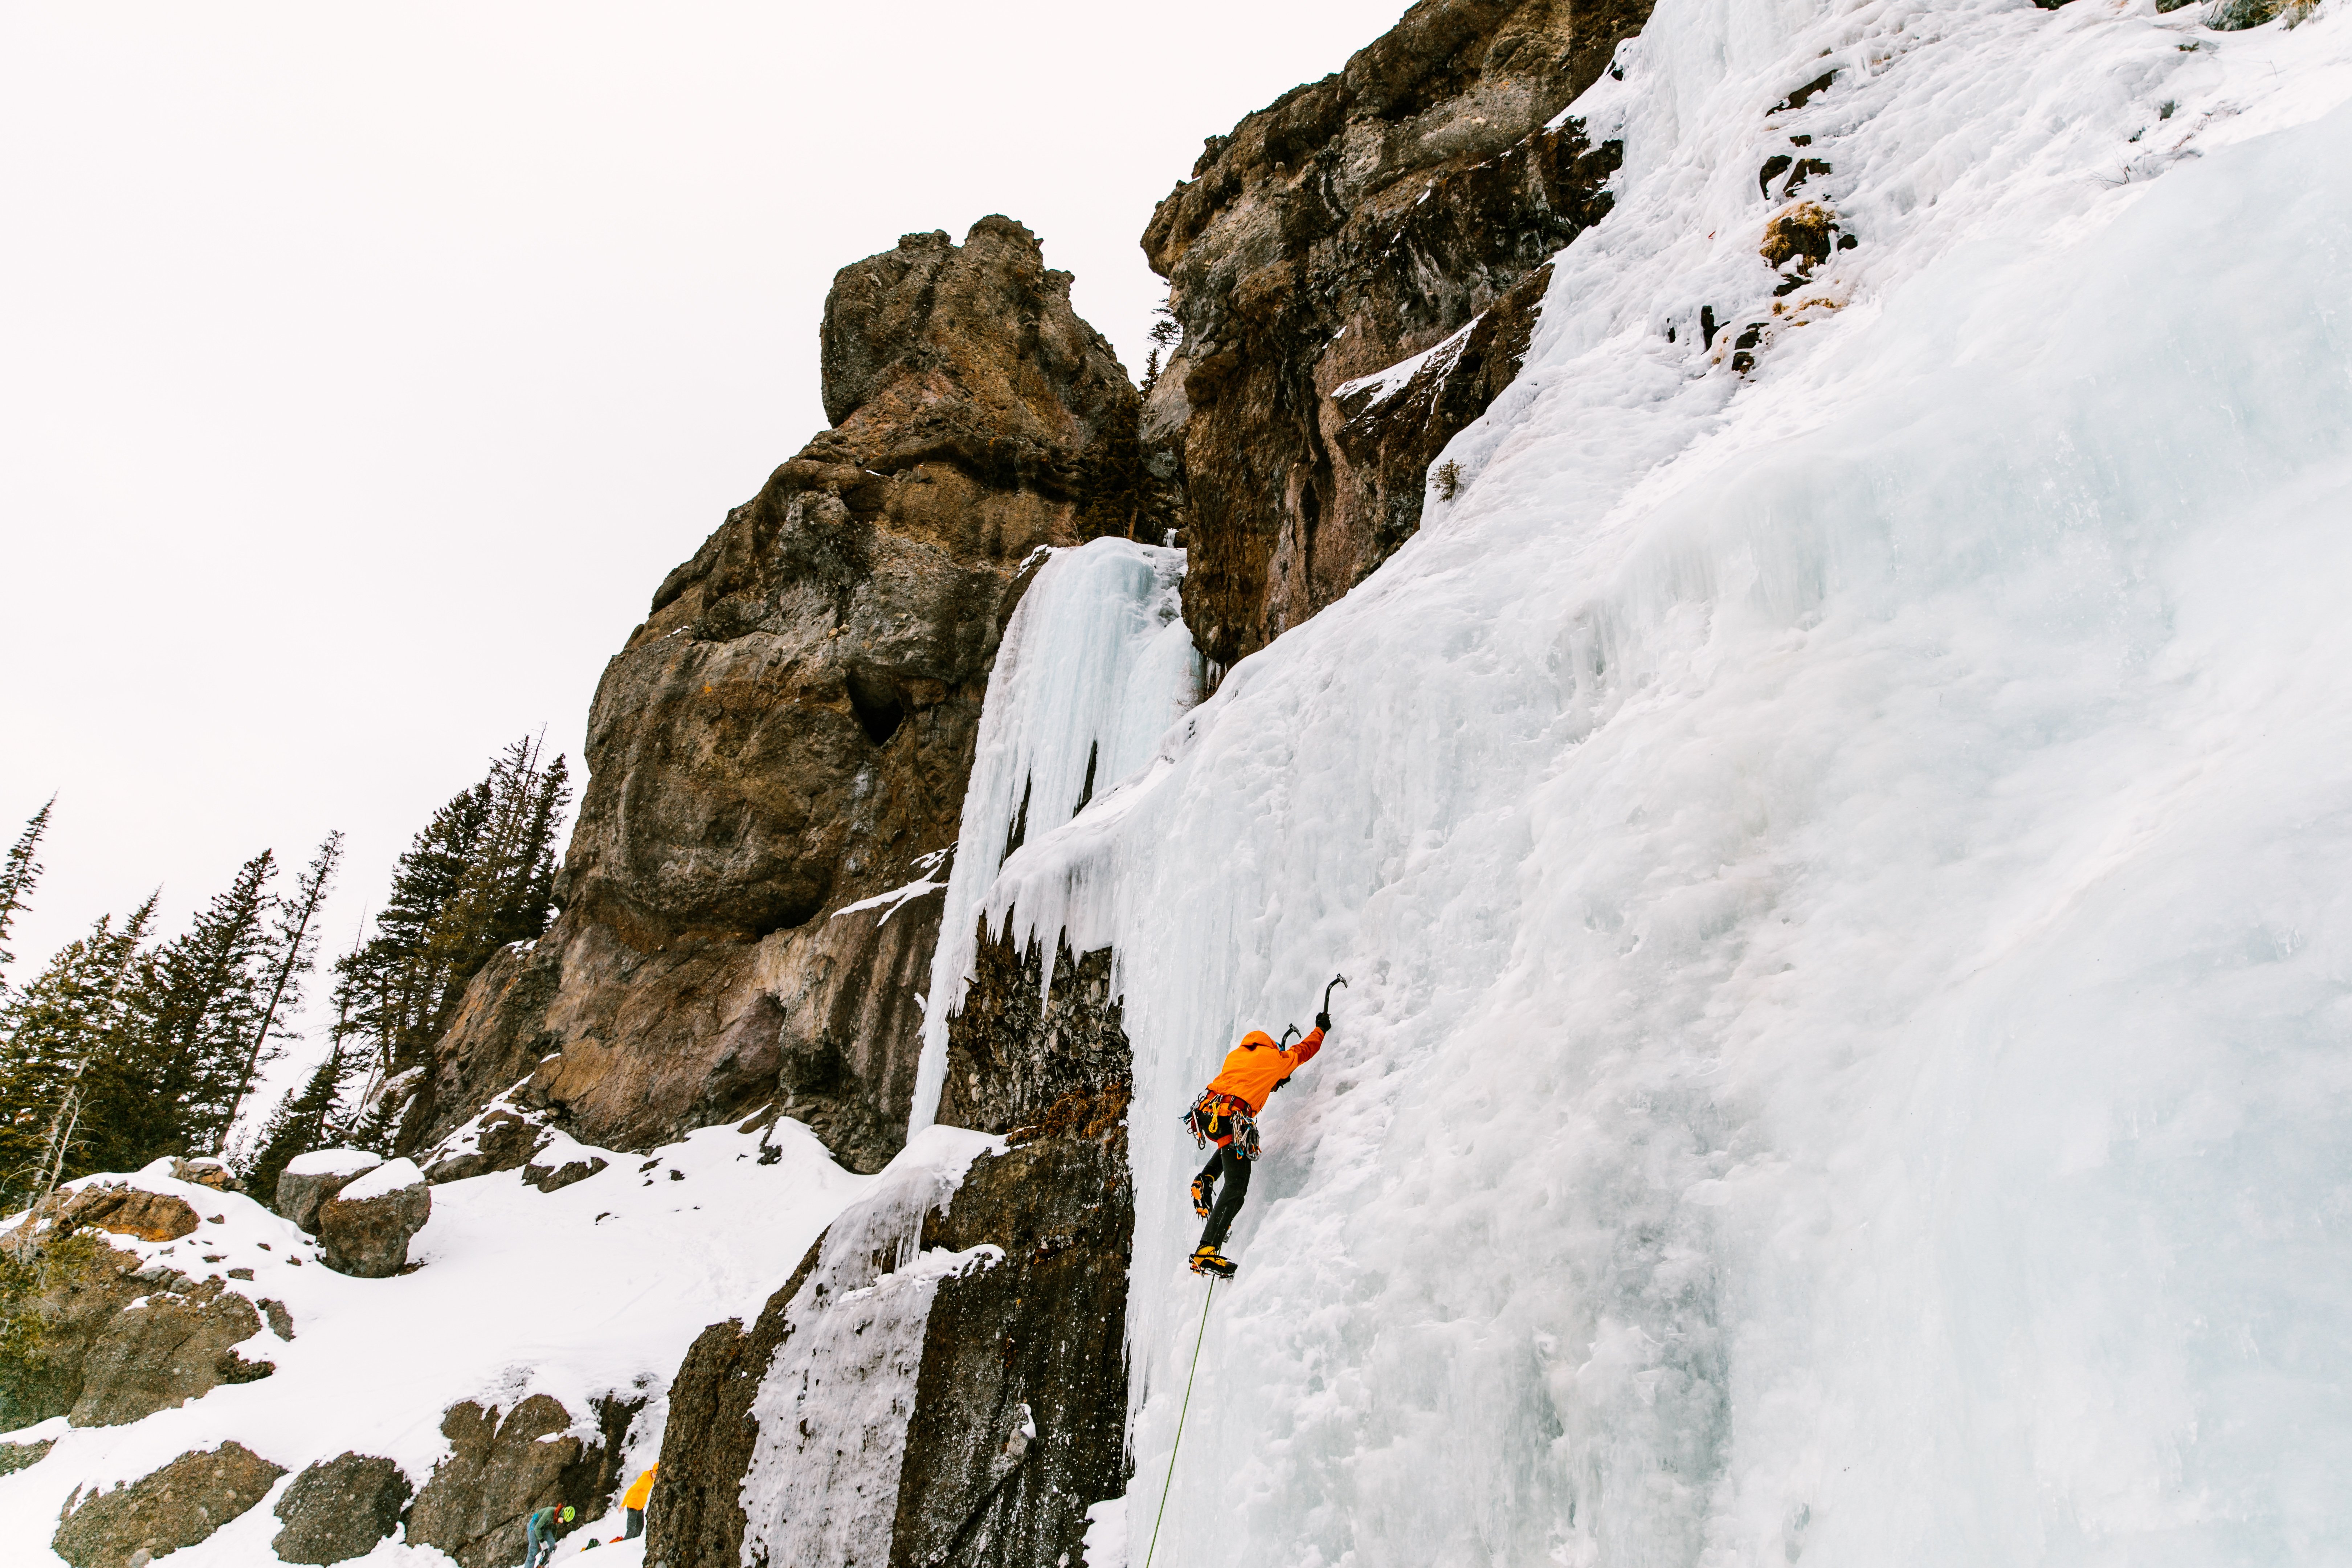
[1143, 0, 1651, 665]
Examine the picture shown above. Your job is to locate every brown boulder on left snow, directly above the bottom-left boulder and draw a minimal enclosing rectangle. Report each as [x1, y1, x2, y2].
[68, 1274, 278, 1427]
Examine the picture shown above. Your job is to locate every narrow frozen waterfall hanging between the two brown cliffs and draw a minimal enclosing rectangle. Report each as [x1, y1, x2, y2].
[908, 538, 1202, 1133]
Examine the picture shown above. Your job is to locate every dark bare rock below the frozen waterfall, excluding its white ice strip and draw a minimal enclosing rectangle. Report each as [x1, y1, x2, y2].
[647, 926, 1134, 1568]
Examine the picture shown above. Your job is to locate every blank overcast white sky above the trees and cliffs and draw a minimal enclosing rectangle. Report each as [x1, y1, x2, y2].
[0, 0, 1404, 1114]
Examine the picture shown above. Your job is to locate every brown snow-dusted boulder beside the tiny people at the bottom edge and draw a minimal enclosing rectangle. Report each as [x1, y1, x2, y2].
[407, 1394, 642, 1568]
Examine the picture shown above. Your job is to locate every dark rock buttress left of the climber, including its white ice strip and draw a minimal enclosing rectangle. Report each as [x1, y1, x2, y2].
[647, 926, 1134, 1568]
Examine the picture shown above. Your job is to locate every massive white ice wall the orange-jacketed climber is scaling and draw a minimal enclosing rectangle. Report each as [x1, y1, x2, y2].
[964, 0, 2352, 1568]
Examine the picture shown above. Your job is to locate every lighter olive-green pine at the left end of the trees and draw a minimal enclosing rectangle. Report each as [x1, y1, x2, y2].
[0, 893, 155, 1208]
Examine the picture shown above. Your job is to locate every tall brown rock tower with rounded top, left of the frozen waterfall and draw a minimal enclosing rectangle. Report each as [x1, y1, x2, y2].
[407, 219, 1162, 1171]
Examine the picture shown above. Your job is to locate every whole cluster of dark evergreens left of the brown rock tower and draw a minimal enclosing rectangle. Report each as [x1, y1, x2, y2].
[0, 738, 572, 1213]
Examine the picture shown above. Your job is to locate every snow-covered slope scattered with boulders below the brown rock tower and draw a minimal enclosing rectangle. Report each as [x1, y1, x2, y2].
[0, 1119, 879, 1568]
